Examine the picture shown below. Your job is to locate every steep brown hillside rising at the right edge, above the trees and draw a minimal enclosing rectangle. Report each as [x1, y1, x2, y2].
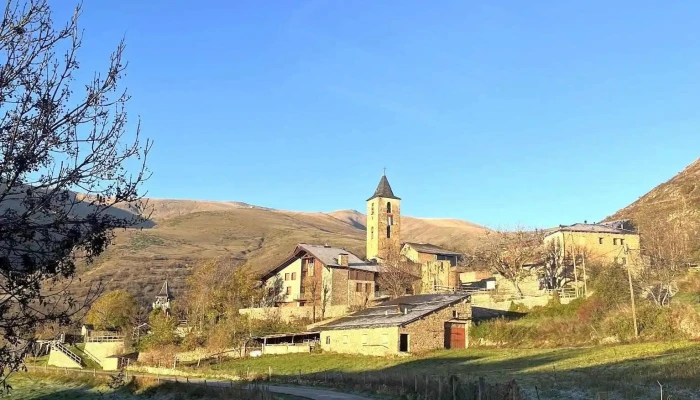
[606, 159, 700, 221]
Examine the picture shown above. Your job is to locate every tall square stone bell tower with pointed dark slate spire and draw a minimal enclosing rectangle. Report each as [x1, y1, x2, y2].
[367, 175, 401, 260]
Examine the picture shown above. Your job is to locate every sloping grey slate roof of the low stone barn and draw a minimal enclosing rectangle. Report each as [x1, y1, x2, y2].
[317, 294, 470, 331]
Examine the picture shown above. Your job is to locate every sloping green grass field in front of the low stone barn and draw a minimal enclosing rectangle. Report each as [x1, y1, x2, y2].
[192, 341, 700, 399]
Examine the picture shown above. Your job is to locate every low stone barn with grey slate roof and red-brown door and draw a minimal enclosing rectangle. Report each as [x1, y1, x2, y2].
[317, 294, 472, 356]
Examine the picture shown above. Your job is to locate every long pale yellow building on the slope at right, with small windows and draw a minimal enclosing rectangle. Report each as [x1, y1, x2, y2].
[544, 220, 639, 265]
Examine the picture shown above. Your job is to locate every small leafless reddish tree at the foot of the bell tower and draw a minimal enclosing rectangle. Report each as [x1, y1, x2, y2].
[377, 241, 421, 298]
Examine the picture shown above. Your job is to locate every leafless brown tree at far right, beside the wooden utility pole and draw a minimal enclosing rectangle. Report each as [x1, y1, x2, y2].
[632, 218, 700, 305]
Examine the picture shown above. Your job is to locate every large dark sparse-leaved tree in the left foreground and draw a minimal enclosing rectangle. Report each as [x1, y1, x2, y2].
[0, 0, 151, 384]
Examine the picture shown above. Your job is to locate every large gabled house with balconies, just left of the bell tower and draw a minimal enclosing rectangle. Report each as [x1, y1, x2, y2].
[262, 243, 377, 309]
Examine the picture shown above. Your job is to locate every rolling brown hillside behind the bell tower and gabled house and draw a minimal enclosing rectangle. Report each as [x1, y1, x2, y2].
[71, 199, 486, 301]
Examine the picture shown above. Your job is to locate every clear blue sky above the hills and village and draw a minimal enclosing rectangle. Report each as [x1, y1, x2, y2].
[64, 0, 700, 227]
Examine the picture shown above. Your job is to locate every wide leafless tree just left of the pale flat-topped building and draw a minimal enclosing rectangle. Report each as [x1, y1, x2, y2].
[476, 229, 543, 296]
